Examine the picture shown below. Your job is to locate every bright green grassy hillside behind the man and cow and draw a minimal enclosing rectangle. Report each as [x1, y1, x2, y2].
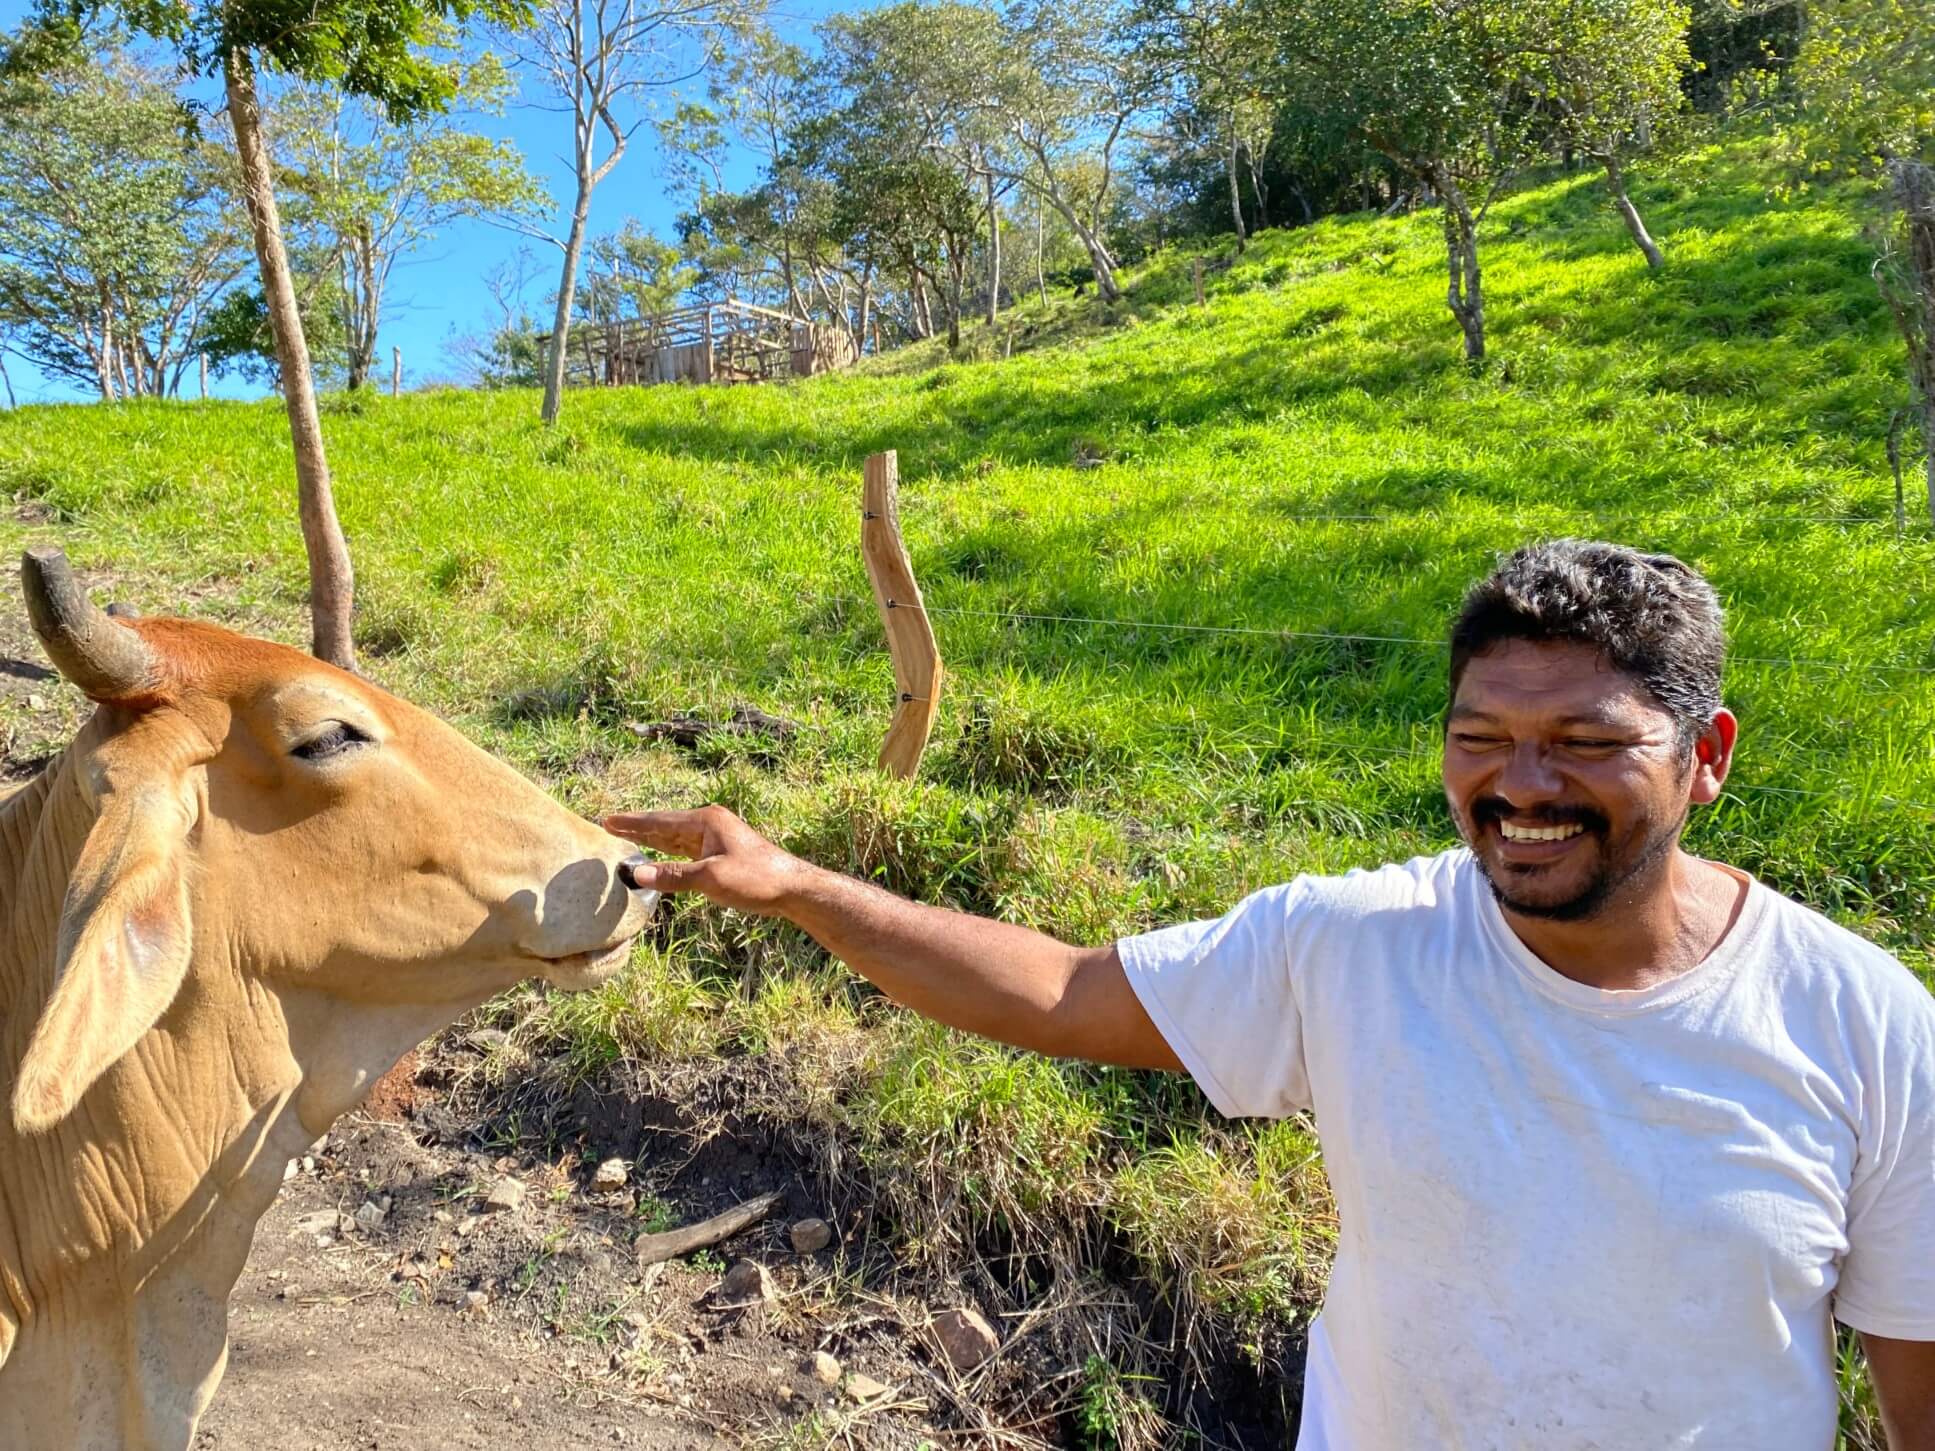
[0, 136, 1935, 1439]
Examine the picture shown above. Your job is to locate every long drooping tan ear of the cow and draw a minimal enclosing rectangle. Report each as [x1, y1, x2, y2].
[14, 776, 195, 1134]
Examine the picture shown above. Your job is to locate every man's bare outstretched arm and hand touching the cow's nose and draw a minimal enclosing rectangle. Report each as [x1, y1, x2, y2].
[604, 807, 1182, 1072]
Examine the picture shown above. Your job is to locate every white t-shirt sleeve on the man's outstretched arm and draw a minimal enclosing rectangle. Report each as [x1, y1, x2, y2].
[1116, 878, 1310, 1118]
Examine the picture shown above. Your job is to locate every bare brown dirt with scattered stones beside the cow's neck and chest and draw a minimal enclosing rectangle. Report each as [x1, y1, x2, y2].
[197, 1052, 1013, 1451]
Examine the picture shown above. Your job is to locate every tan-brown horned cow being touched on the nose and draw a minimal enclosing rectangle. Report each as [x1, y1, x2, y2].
[0, 549, 656, 1451]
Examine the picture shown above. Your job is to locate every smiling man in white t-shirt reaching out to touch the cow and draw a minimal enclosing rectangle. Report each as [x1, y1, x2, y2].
[606, 542, 1935, 1451]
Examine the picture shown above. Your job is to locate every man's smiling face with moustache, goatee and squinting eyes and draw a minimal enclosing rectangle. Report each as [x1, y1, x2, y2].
[1444, 640, 1734, 921]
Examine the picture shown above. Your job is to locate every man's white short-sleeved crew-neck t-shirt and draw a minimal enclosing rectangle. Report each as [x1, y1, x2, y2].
[1120, 851, 1935, 1451]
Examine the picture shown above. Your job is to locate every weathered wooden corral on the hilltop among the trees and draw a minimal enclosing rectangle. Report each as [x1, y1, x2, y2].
[565, 302, 857, 387]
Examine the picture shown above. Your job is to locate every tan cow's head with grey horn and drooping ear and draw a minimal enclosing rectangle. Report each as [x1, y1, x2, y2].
[12, 549, 656, 1132]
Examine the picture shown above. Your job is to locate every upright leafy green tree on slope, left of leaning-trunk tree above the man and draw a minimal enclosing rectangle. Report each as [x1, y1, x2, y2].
[1277, 0, 1562, 362]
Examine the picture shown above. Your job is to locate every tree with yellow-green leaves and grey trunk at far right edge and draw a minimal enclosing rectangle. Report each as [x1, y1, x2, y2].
[1794, 0, 1935, 518]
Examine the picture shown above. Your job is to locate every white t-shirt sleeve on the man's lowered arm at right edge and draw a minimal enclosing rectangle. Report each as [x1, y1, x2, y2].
[1834, 973, 1935, 1341]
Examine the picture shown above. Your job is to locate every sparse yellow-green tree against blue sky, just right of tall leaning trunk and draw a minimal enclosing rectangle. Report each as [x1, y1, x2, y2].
[273, 54, 544, 391]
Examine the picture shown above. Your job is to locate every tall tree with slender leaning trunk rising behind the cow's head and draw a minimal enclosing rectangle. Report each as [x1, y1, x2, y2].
[10, 0, 522, 669]
